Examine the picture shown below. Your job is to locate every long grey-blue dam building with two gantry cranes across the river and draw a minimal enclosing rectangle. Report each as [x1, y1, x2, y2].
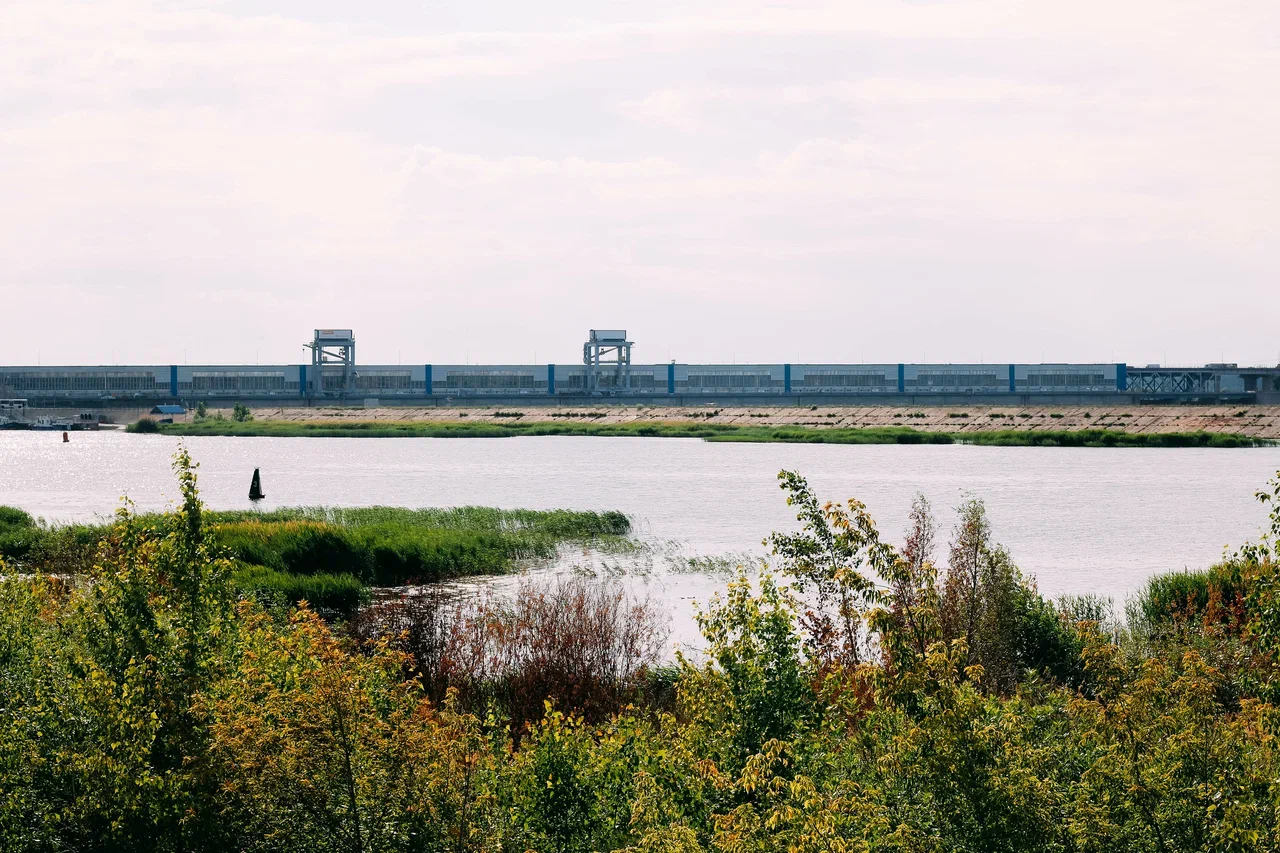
[0, 329, 1280, 407]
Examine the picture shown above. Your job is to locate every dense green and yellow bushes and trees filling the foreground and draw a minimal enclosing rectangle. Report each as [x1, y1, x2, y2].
[0, 452, 1280, 853]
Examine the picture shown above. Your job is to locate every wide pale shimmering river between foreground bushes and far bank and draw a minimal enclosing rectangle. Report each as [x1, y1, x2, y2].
[0, 432, 1280, 638]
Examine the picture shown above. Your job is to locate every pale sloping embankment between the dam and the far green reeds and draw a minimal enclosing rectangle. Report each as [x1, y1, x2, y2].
[186, 403, 1280, 439]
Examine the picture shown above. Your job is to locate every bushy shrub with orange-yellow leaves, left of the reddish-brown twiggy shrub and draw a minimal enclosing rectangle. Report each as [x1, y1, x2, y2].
[211, 608, 493, 852]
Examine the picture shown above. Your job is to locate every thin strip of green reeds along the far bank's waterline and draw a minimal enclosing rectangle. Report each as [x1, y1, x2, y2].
[147, 420, 1275, 447]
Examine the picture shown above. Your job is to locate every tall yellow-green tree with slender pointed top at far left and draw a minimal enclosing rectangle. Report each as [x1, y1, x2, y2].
[17, 450, 236, 850]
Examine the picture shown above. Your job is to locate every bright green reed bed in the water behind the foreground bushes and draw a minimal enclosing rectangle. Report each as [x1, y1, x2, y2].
[0, 499, 631, 613]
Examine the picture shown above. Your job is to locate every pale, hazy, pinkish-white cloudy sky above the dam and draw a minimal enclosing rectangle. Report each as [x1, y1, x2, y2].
[0, 0, 1280, 365]
